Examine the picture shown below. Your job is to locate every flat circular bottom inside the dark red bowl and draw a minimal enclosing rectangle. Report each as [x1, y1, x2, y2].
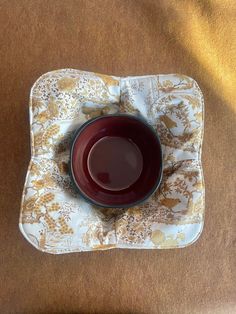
[87, 136, 143, 191]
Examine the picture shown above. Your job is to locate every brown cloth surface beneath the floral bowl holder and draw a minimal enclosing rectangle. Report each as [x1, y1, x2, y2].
[0, 0, 236, 314]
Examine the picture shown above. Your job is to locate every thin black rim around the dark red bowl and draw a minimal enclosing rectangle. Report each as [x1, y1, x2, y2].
[69, 113, 163, 208]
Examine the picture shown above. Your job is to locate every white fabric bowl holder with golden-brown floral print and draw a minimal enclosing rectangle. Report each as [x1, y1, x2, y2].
[19, 69, 204, 254]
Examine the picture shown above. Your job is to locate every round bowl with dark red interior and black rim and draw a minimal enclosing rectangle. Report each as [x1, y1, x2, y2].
[70, 114, 162, 208]
